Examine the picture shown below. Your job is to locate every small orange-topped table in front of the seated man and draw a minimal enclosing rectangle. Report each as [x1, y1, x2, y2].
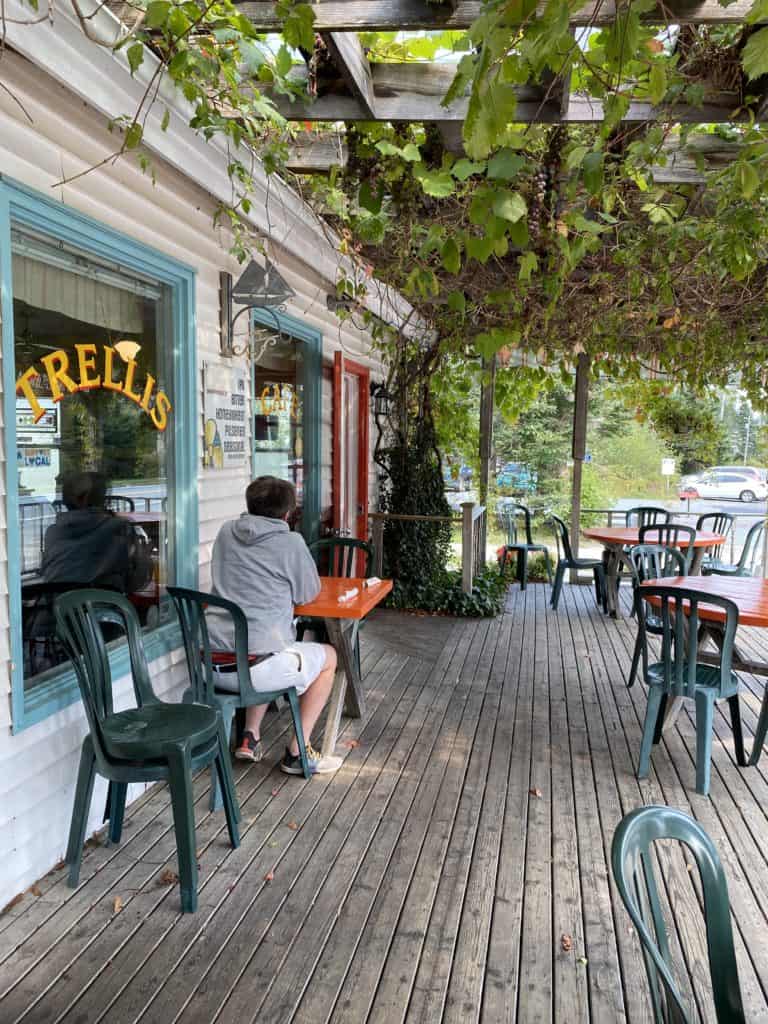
[294, 577, 392, 756]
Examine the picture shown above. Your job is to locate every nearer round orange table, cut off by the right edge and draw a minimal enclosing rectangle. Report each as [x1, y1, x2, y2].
[641, 575, 768, 763]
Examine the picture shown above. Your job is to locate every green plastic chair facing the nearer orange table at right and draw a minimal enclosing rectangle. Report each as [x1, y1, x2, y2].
[635, 584, 746, 797]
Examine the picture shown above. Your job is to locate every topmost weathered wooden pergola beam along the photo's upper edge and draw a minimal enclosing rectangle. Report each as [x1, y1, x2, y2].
[238, 0, 765, 32]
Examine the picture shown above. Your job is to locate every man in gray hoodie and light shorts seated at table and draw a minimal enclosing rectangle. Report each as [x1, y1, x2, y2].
[206, 476, 341, 775]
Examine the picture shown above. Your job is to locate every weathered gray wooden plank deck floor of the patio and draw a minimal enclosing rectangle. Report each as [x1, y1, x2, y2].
[0, 585, 768, 1024]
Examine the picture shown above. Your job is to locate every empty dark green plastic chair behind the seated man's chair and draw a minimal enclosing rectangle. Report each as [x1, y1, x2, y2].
[53, 589, 240, 913]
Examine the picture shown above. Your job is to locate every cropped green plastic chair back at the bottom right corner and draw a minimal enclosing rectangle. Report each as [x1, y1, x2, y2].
[610, 807, 745, 1024]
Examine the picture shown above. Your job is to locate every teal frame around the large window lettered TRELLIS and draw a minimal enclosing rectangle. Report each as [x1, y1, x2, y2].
[0, 175, 199, 733]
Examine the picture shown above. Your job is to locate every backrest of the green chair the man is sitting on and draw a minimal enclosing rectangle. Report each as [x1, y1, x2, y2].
[168, 587, 251, 705]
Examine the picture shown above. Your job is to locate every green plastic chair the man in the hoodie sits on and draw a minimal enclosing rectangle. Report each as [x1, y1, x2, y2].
[168, 587, 310, 810]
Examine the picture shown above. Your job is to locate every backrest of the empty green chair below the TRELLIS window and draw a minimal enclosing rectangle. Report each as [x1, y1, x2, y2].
[53, 588, 158, 762]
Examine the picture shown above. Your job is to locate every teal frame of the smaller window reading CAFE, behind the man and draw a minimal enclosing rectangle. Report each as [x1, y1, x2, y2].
[251, 307, 323, 544]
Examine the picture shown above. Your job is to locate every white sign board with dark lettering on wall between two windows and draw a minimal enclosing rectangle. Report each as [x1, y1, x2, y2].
[203, 366, 248, 469]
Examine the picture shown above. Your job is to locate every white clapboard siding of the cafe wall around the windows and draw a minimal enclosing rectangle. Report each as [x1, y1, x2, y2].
[0, 49, 385, 908]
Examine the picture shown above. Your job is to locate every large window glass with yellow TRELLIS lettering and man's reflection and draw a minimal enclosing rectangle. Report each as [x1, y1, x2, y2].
[10, 227, 174, 690]
